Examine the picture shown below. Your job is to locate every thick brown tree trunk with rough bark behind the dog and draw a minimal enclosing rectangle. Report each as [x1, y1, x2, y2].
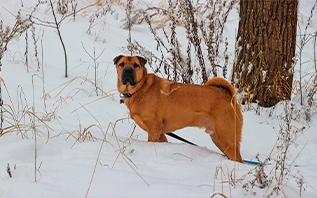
[232, 0, 298, 107]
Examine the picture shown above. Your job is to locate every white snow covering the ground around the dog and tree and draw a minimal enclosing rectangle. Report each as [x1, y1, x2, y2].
[0, 0, 317, 198]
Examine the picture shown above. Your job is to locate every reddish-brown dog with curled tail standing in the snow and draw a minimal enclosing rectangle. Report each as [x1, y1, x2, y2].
[113, 55, 243, 162]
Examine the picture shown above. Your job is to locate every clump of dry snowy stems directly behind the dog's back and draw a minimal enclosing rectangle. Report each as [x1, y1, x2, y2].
[125, 0, 238, 83]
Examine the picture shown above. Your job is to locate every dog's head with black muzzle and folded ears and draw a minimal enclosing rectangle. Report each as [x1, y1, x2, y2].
[113, 55, 147, 94]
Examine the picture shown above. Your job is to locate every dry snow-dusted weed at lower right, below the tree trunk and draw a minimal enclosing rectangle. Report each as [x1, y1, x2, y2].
[239, 102, 308, 197]
